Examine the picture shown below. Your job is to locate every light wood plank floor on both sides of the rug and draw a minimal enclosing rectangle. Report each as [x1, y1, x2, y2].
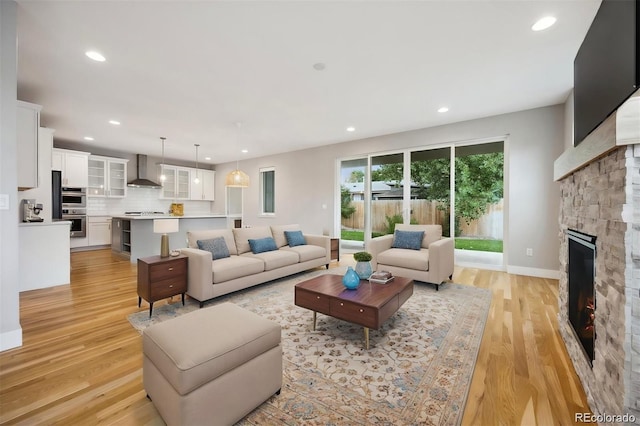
[0, 250, 589, 425]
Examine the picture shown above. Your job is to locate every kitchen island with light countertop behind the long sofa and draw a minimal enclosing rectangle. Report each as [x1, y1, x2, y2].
[111, 214, 235, 263]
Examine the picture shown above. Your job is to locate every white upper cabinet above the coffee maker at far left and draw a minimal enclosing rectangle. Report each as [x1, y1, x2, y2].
[16, 101, 42, 191]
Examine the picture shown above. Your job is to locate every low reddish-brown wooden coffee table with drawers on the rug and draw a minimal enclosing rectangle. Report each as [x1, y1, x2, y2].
[295, 274, 413, 349]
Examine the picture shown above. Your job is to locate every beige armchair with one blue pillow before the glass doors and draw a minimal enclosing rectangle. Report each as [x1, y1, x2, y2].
[367, 224, 454, 290]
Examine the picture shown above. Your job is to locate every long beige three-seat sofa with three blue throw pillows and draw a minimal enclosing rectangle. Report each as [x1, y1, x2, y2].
[181, 225, 331, 307]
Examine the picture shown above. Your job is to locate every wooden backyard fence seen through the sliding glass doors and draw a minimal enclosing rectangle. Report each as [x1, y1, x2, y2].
[342, 200, 504, 239]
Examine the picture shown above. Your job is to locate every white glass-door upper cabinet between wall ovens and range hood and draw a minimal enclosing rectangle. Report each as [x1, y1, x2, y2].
[87, 155, 129, 198]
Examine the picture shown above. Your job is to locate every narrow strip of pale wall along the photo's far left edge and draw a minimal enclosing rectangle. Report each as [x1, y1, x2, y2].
[0, 0, 22, 351]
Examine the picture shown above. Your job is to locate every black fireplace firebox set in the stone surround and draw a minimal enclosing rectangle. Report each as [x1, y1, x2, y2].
[567, 230, 596, 367]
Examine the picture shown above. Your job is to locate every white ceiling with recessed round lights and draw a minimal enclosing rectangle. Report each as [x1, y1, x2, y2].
[18, 0, 600, 164]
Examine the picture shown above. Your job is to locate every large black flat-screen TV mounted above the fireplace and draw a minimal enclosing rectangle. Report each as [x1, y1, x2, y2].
[573, 0, 640, 145]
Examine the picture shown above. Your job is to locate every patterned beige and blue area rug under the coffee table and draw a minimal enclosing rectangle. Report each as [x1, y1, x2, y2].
[129, 269, 491, 425]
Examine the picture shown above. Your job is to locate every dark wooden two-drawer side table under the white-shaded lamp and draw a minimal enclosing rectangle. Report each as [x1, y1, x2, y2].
[138, 254, 188, 316]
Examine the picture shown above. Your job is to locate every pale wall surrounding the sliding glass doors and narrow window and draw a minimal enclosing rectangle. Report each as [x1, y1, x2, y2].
[214, 105, 565, 277]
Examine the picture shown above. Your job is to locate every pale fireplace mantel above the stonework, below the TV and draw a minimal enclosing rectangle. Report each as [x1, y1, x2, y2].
[553, 90, 640, 181]
